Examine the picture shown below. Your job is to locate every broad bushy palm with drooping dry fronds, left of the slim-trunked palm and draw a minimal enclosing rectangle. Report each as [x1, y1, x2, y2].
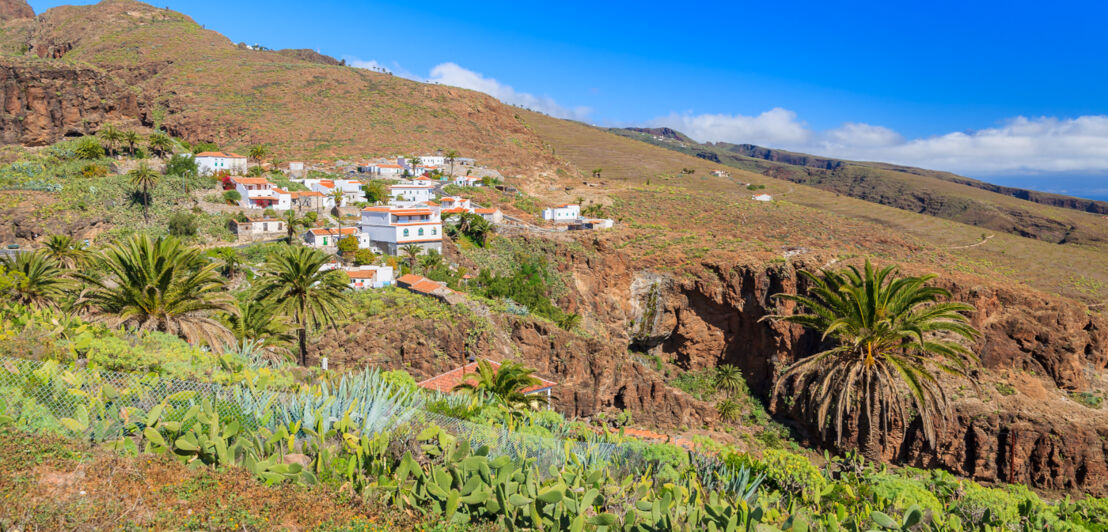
[79, 235, 235, 350]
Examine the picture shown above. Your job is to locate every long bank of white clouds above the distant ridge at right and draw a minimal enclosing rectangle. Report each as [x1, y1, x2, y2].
[650, 108, 1108, 175]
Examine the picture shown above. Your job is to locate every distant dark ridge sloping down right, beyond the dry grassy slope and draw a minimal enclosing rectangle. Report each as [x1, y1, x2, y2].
[609, 129, 1108, 247]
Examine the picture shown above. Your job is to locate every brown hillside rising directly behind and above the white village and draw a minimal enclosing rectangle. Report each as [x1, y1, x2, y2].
[0, 0, 554, 173]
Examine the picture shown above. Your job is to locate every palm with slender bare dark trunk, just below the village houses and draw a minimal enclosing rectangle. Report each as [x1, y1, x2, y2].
[256, 246, 349, 366]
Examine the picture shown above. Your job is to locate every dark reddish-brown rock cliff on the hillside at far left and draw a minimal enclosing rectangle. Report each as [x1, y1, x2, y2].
[0, 62, 139, 145]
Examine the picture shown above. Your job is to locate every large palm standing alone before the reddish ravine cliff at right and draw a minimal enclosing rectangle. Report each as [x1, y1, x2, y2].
[768, 260, 979, 456]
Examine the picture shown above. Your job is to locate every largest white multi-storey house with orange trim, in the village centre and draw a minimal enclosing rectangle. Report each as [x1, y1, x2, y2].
[360, 205, 442, 255]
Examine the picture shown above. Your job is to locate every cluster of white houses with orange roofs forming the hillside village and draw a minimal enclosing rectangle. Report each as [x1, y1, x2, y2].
[204, 152, 615, 294]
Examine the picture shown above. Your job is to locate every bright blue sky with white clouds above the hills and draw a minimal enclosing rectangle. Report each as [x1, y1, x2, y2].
[30, 0, 1108, 196]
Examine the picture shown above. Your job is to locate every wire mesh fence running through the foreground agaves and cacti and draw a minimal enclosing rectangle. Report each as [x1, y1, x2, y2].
[0, 357, 664, 471]
